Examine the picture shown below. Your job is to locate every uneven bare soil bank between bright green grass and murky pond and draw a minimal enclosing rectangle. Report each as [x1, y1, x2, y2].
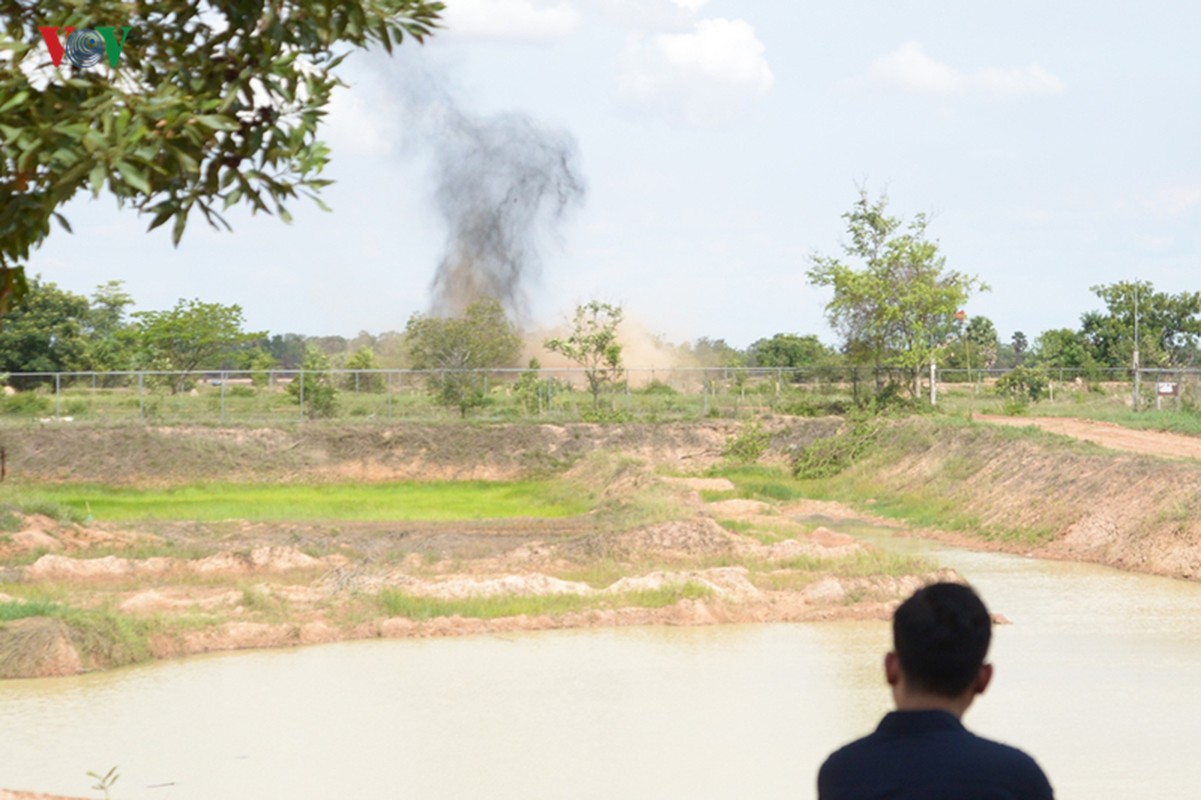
[0, 454, 943, 676]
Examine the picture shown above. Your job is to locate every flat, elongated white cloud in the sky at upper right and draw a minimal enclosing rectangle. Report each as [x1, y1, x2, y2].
[867, 42, 1064, 96]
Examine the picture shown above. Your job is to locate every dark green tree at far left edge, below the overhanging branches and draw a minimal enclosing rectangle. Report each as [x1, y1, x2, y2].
[0, 277, 89, 388]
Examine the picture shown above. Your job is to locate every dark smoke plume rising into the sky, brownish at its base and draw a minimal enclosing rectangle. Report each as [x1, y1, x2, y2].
[398, 65, 585, 320]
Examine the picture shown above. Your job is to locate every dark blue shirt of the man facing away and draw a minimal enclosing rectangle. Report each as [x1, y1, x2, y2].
[818, 711, 1053, 800]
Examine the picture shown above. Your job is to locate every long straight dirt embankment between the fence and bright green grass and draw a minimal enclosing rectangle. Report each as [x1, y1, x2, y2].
[0, 419, 839, 484]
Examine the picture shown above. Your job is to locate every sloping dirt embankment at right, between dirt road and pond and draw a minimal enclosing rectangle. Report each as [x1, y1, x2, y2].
[847, 419, 1201, 580]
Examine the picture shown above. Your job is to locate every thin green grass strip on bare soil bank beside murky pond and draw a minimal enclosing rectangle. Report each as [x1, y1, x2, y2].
[376, 581, 712, 620]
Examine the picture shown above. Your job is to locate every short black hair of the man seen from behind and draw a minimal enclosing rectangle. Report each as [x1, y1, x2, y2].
[892, 583, 992, 697]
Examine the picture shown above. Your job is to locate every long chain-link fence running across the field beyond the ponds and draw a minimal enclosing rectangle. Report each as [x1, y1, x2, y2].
[0, 366, 1186, 424]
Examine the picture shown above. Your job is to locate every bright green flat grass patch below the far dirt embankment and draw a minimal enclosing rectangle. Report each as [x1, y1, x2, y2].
[9, 480, 588, 521]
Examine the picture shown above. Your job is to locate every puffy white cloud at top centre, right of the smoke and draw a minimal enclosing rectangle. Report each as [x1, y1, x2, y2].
[619, 19, 773, 126]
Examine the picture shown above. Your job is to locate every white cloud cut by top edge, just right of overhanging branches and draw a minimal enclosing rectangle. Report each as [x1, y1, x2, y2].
[442, 0, 582, 42]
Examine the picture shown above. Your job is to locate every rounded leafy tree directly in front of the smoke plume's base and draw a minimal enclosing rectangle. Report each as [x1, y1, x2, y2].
[405, 298, 521, 417]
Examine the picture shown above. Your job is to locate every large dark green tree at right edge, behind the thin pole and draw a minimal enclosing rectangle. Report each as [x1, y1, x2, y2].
[1081, 281, 1201, 368]
